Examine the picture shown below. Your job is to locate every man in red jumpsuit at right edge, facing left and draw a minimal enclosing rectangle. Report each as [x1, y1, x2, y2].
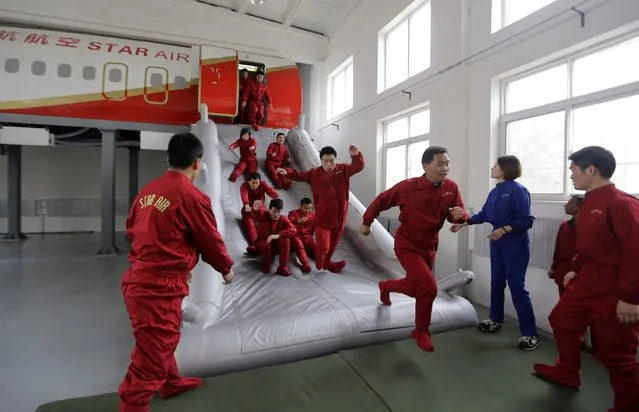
[534, 146, 639, 412]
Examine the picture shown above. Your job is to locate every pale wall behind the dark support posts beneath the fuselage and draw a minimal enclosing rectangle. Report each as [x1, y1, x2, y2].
[0, 146, 167, 233]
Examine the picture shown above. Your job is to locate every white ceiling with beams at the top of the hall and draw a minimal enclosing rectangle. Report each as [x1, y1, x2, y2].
[196, 0, 362, 37]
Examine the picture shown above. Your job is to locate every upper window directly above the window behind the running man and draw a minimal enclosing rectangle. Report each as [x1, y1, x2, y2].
[378, 0, 431, 92]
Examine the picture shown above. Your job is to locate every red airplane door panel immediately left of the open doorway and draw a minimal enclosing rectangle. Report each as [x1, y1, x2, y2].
[198, 46, 239, 117]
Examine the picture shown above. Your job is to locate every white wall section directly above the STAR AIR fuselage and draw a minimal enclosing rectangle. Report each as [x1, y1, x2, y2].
[0, 0, 328, 64]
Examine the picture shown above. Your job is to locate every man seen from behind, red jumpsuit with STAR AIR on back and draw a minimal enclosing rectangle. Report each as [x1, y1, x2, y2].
[119, 133, 234, 412]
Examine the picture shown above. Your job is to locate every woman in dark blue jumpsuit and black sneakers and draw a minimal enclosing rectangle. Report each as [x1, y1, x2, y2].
[451, 156, 540, 351]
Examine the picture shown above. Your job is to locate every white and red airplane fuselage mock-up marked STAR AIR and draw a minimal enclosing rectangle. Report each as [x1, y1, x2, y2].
[0, 26, 302, 129]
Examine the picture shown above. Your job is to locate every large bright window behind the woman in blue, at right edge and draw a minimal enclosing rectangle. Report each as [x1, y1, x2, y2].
[502, 33, 639, 198]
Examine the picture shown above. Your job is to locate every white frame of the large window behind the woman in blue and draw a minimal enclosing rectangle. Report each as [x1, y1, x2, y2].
[498, 31, 639, 201]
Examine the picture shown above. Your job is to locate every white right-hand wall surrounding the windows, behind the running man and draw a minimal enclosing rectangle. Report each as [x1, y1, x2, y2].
[313, 0, 639, 330]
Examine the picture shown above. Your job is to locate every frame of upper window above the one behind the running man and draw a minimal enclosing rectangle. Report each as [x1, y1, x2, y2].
[377, 0, 433, 94]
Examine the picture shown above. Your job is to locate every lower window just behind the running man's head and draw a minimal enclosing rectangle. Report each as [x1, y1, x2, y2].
[383, 108, 430, 190]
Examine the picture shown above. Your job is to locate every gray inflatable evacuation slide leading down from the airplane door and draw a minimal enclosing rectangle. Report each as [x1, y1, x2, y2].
[176, 107, 477, 376]
